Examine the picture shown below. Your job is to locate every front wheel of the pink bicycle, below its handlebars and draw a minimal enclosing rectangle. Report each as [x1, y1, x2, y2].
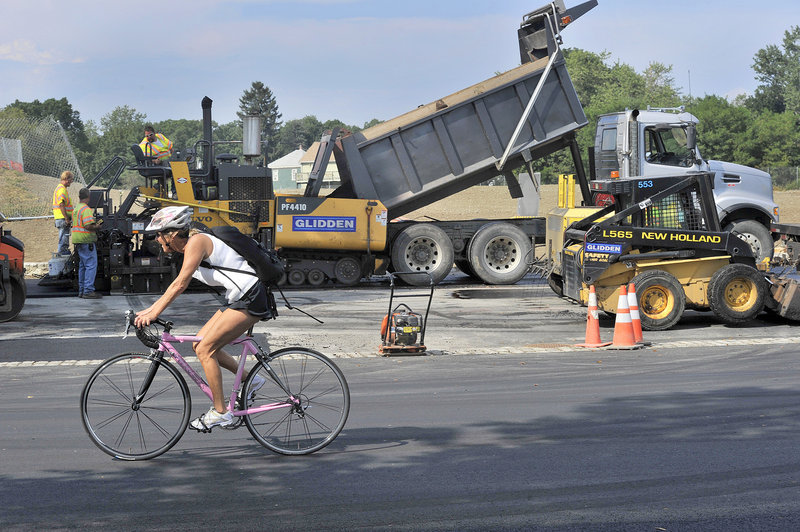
[81, 353, 192, 460]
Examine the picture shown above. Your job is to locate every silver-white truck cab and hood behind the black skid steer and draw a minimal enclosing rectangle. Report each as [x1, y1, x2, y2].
[594, 107, 779, 261]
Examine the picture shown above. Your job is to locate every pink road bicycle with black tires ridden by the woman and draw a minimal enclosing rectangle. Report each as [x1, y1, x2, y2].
[80, 310, 350, 460]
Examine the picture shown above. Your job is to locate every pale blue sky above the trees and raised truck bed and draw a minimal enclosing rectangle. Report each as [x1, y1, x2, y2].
[0, 0, 800, 129]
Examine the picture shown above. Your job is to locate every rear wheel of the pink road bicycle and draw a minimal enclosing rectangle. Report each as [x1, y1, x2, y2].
[244, 347, 350, 455]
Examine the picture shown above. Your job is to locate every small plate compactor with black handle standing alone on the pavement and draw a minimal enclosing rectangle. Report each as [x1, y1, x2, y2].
[378, 272, 434, 356]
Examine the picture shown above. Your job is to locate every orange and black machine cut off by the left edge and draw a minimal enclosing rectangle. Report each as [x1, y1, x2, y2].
[0, 213, 27, 322]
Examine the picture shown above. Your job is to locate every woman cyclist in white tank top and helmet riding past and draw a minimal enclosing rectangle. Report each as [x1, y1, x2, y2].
[134, 207, 274, 431]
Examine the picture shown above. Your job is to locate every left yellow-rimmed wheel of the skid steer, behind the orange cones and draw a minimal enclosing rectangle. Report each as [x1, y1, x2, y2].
[631, 270, 686, 331]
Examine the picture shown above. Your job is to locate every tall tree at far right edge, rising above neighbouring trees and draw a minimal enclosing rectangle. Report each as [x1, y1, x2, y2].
[748, 26, 800, 115]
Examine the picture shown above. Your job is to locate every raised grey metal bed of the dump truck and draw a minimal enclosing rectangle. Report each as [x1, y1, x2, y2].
[334, 54, 587, 218]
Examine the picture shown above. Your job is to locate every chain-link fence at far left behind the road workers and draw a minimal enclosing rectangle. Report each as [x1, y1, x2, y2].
[0, 117, 86, 218]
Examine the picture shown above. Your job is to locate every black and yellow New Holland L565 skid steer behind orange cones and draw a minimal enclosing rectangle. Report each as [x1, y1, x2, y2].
[547, 172, 800, 330]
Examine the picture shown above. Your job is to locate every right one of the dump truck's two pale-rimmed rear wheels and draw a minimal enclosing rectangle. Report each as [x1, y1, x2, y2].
[467, 222, 531, 284]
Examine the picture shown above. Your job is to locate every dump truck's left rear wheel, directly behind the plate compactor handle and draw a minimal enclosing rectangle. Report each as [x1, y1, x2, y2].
[392, 224, 453, 286]
